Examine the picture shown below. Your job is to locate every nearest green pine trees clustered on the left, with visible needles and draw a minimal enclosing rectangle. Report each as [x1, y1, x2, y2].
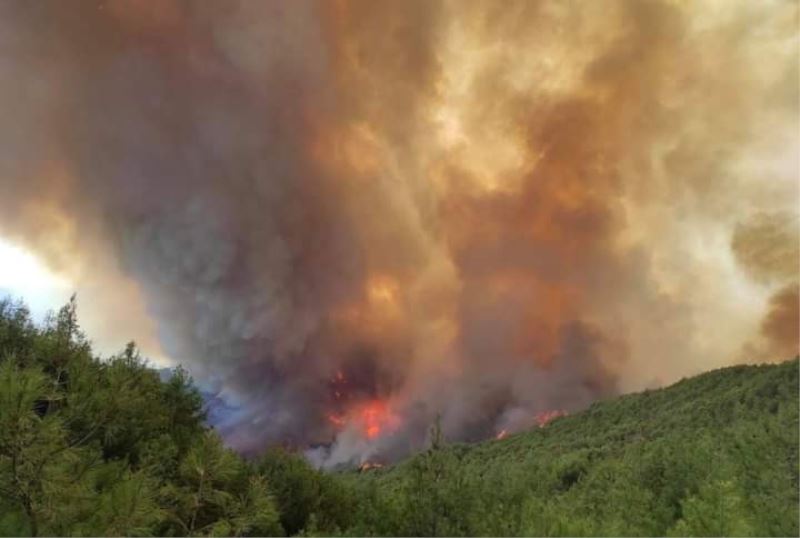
[0, 298, 282, 536]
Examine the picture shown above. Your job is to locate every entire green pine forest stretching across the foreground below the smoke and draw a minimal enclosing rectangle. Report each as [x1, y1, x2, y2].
[0, 300, 799, 536]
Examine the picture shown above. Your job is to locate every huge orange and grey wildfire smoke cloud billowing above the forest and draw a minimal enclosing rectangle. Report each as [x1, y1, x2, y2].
[0, 0, 799, 463]
